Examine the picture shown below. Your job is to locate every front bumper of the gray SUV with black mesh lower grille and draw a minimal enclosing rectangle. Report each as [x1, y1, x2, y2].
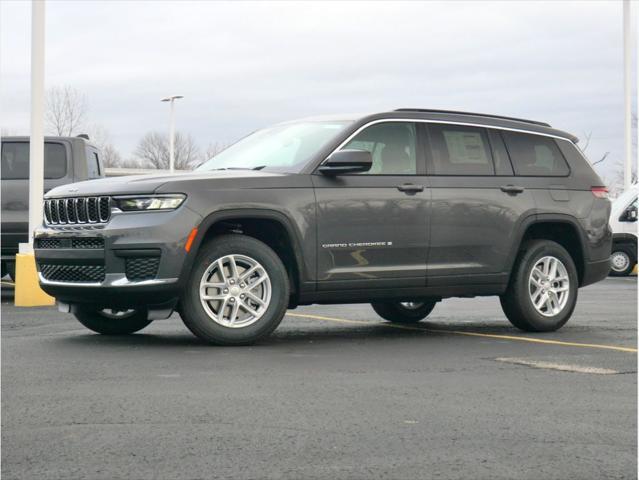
[34, 206, 201, 307]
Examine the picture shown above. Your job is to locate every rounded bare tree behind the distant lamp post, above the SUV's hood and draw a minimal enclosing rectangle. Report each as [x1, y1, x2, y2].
[134, 132, 201, 170]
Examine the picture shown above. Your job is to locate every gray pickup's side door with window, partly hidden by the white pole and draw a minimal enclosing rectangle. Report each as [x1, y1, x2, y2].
[0, 141, 73, 251]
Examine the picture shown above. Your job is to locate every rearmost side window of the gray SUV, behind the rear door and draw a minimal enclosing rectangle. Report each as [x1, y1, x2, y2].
[502, 131, 569, 177]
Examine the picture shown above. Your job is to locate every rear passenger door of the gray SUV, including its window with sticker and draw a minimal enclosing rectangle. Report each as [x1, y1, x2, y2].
[424, 123, 535, 286]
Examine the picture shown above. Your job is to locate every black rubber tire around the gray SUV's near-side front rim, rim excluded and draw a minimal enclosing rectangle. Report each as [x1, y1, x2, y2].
[181, 235, 289, 345]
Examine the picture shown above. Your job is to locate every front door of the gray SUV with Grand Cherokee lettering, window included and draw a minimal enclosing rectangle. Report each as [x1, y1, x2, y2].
[313, 122, 430, 290]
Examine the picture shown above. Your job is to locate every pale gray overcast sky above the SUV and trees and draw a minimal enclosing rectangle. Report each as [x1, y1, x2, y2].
[0, 0, 636, 180]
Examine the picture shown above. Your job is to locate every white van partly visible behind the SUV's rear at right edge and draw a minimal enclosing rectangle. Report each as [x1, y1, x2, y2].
[610, 185, 639, 277]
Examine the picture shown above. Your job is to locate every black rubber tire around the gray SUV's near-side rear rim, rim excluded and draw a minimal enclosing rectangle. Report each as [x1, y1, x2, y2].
[509, 240, 579, 332]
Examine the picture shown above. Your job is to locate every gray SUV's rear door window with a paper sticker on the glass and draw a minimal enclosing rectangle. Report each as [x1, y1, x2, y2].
[428, 124, 494, 175]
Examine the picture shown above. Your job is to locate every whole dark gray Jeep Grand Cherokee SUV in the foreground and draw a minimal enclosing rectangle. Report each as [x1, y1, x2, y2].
[35, 109, 611, 345]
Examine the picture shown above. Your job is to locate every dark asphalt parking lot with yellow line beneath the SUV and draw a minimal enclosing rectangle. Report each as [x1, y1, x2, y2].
[2, 277, 637, 480]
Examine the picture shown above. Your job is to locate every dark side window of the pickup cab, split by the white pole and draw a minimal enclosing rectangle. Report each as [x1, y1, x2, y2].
[2, 142, 67, 180]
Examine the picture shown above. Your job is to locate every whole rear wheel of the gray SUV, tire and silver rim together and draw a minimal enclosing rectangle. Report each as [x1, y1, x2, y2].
[500, 240, 579, 332]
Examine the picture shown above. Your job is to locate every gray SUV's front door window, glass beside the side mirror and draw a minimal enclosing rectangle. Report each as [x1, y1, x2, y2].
[343, 122, 417, 175]
